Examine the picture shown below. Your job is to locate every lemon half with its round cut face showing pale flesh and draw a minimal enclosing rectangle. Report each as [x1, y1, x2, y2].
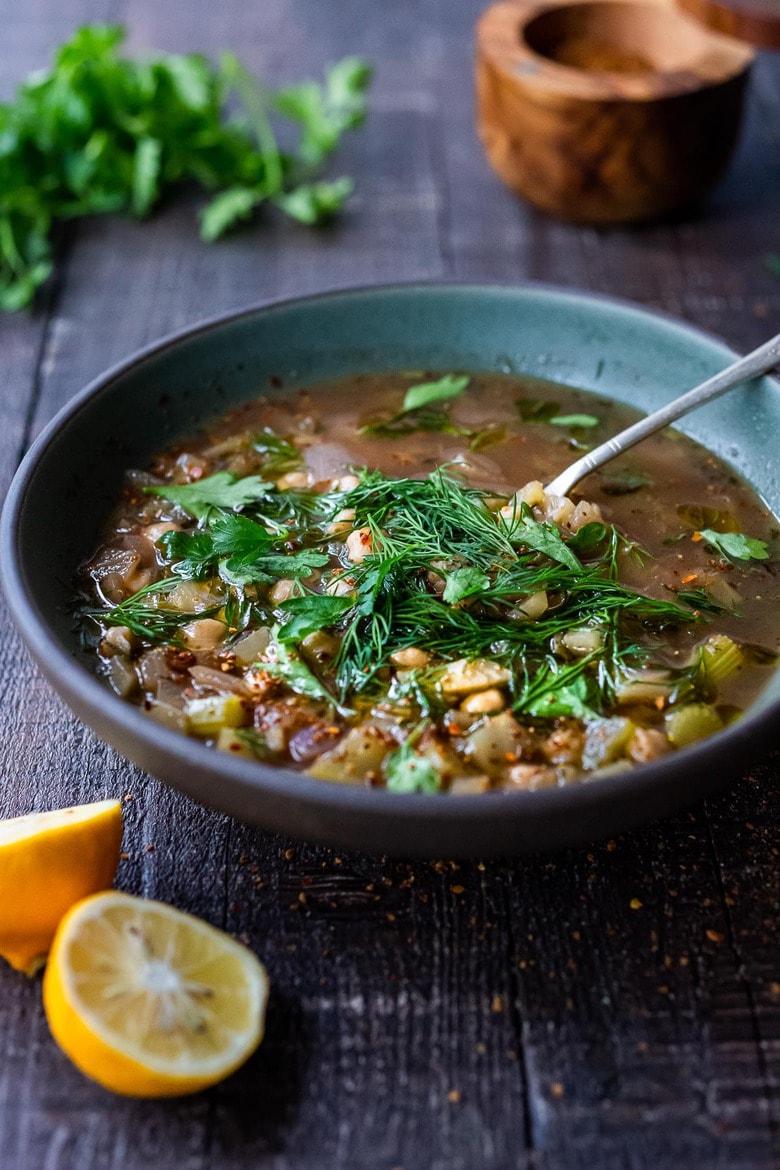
[43, 892, 273, 1097]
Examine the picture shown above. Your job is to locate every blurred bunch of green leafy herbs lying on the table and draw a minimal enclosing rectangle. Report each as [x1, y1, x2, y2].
[0, 25, 371, 310]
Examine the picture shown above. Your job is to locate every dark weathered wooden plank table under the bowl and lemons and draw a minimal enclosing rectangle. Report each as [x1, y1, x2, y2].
[0, 0, 780, 1170]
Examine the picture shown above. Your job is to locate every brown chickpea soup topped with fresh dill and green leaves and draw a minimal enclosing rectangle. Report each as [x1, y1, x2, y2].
[80, 371, 780, 794]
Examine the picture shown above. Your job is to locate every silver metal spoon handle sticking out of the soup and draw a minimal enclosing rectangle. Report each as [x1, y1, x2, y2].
[545, 333, 780, 496]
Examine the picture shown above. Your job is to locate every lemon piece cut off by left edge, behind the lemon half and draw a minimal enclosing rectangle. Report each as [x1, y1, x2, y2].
[0, 800, 122, 975]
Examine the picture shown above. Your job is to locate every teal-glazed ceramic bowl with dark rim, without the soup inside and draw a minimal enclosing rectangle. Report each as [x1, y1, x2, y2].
[1, 285, 780, 856]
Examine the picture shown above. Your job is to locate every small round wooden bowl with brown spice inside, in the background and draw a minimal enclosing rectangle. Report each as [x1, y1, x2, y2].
[476, 0, 754, 223]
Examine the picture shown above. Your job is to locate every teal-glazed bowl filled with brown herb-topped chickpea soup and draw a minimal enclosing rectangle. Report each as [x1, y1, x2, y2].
[2, 284, 780, 856]
